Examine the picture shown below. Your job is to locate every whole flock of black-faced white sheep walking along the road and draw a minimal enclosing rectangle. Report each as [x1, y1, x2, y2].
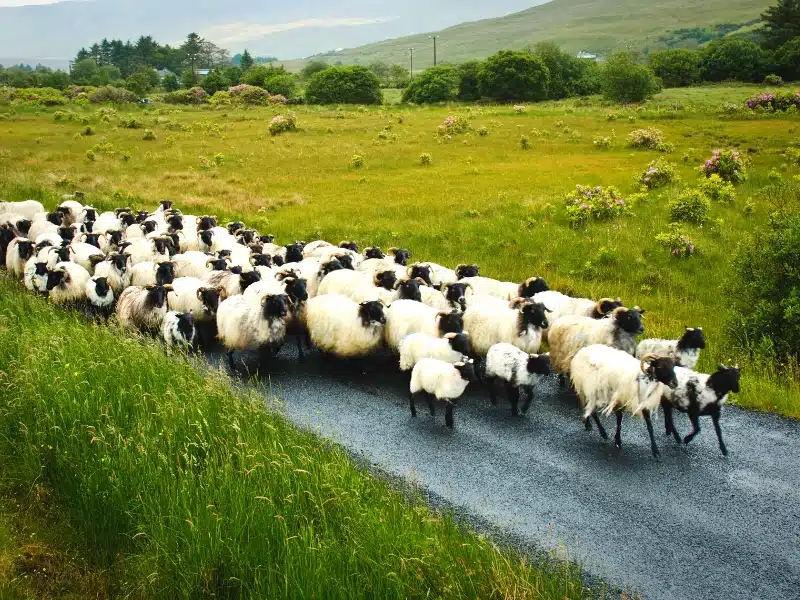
[0, 192, 739, 456]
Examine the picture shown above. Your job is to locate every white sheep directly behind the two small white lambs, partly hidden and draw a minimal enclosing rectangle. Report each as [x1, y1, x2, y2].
[384, 300, 464, 353]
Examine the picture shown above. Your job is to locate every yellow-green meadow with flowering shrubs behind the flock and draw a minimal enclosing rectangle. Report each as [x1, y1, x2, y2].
[0, 85, 800, 417]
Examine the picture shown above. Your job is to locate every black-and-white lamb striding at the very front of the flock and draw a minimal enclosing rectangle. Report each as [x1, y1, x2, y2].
[661, 365, 741, 456]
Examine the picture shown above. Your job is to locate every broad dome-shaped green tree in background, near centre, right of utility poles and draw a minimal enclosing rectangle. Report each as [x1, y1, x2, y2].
[478, 50, 550, 100]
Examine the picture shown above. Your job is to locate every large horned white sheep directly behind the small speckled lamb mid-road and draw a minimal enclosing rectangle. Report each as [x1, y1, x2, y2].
[464, 297, 548, 356]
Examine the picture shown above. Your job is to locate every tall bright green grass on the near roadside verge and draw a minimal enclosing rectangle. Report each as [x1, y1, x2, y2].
[0, 278, 582, 599]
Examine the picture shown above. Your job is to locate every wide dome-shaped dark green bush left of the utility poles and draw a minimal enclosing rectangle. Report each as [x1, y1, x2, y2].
[306, 66, 383, 104]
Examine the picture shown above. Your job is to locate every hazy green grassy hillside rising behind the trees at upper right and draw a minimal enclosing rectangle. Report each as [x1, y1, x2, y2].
[278, 0, 774, 71]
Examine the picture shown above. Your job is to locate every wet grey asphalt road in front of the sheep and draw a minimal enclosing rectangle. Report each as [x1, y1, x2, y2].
[208, 345, 800, 600]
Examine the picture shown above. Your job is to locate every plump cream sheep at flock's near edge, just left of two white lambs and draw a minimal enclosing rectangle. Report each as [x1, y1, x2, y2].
[305, 294, 386, 358]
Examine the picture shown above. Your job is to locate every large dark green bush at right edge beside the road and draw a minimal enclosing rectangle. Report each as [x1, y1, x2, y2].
[727, 210, 800, 359]
